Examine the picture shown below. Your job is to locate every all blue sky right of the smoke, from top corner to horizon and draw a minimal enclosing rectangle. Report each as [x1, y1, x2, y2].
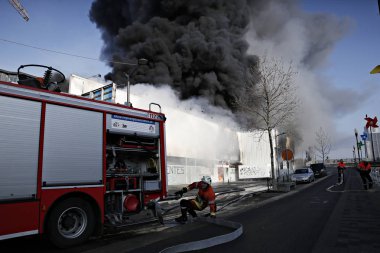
[302, 0, 380, 157]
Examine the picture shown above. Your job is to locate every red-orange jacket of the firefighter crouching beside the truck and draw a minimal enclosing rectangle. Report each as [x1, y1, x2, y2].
[187, 182, 216, 215]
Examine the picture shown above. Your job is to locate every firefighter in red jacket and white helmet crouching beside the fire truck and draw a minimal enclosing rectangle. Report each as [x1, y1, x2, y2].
[175, 177, 216, 223]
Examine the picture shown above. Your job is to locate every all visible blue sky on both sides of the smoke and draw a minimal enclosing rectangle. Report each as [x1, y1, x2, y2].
[0, 0, 380, 158]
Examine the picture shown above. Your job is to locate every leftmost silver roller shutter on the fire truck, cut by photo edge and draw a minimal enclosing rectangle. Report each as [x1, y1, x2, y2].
[0, 95, 41, 201]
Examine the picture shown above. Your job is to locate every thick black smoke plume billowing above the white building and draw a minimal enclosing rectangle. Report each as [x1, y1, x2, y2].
[90, 0, 258, 109]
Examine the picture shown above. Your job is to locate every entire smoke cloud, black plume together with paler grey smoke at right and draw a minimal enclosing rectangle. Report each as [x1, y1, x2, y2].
[90, 0, 354, 156]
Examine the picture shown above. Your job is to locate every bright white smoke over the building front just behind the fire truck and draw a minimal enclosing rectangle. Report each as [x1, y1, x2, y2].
[116, 84, 239, 161]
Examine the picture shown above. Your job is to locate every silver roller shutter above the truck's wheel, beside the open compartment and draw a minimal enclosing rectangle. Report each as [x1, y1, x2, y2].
[42, 104, 103, 187]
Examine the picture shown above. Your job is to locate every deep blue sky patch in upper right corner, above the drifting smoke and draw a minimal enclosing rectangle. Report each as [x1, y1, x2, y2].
[302, 0, 380, 88]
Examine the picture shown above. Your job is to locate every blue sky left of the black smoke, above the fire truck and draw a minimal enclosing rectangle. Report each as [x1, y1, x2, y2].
[0, 0, 110, 76]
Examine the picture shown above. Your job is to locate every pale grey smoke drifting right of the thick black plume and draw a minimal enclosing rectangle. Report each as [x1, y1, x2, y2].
[247, 1, 357, 155]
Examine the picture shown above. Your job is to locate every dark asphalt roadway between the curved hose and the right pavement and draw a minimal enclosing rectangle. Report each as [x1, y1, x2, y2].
[204, 170, 342, 253]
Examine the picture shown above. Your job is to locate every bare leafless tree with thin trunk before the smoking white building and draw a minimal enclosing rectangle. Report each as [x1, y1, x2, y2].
[235, 57, 298, 183]
